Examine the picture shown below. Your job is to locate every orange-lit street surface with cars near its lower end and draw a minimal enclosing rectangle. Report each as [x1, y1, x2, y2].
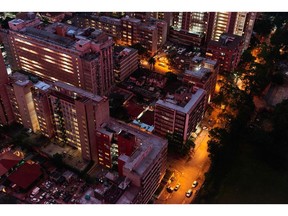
[155, 130, 210, 204]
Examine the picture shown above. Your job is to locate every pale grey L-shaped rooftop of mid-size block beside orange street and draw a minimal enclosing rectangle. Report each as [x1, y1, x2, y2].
[156, 89, 205, 114]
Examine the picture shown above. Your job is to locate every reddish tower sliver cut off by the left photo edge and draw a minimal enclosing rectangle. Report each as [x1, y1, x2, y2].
[0, 52, 14, 125]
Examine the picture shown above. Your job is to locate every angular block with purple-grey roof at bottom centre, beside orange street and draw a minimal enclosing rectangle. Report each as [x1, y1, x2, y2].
[97, 120, 168, 204]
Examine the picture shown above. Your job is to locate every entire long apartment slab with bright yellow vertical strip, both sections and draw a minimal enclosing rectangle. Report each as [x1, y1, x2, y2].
[7, 72, 109, 161]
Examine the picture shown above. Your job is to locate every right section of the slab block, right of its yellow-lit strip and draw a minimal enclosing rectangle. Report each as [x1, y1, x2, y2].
[49, 82, 109, 161]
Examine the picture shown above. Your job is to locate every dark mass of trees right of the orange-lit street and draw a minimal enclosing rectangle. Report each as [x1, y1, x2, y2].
[196, 13, 288, 201]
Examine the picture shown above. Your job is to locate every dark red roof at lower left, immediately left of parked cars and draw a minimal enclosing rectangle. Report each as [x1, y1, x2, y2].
[8, 163, 42, 189]
